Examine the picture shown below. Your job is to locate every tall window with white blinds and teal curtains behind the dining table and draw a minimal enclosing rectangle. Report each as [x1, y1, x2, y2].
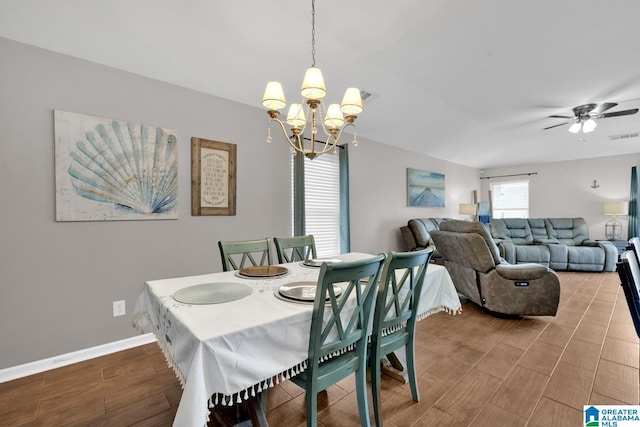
[291, 149, 349, 257]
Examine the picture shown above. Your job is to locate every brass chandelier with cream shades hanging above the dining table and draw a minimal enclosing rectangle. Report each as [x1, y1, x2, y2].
[262, 0, 362, 159]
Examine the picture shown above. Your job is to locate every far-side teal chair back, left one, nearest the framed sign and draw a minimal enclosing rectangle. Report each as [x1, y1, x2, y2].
[218, 239, 271, 271]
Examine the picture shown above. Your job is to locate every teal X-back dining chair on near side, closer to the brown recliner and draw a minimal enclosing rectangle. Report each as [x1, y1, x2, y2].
[369, 246, 435, 427]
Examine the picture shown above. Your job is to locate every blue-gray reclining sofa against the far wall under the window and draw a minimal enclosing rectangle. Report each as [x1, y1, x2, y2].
[490, 218, 618, 272]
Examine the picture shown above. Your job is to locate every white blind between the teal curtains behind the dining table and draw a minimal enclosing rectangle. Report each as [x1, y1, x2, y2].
[304, 154, 340, 257]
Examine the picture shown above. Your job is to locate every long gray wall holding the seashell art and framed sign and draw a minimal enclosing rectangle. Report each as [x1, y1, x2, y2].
[0, 38, 480, 369]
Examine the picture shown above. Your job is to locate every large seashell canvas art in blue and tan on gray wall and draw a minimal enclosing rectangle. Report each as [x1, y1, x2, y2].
[54, 110, 178, 221]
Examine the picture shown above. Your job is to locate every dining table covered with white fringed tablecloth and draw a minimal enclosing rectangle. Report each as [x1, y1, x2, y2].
[133, 252, 461, 427]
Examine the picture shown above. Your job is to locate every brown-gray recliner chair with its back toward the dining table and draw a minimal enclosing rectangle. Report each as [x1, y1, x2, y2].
[431, 220, 560, 316]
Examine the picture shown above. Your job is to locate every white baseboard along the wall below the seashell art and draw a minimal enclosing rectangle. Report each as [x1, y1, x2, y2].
[0, 334, 156, 383]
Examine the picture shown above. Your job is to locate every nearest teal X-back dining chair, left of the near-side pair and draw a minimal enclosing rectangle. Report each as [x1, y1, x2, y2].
[291, 254, 386, 427]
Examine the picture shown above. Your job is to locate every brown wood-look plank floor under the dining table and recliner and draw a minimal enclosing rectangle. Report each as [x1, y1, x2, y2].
[0, 273, 640, 427]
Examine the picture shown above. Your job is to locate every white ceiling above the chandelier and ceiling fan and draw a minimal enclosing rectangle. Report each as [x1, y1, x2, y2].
[0, 0, 640, 168]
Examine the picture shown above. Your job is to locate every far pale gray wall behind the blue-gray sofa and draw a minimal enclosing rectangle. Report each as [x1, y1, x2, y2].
[481, 155, 640, 239]
